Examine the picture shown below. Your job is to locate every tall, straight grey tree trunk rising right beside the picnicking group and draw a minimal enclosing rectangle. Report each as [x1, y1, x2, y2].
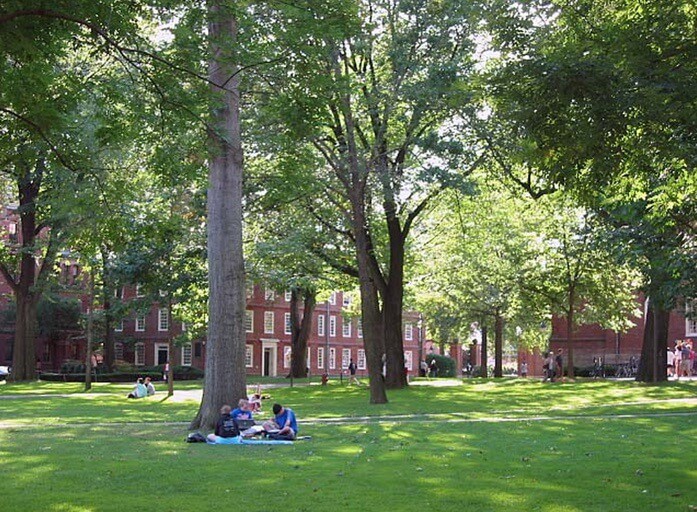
[191, 0, 246, 429]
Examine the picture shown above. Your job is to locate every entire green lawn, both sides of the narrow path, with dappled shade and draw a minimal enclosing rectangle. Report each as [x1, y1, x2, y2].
[0, 379, 697, 512]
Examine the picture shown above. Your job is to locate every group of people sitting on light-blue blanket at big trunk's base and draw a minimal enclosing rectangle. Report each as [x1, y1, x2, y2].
[208, 398, 298, 444]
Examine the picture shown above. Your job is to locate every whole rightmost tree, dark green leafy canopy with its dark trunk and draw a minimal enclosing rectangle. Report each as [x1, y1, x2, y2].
[490, 0, 697, 381]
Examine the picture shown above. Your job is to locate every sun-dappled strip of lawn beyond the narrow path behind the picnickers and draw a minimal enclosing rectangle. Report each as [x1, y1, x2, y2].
[0, 379, 697, 424]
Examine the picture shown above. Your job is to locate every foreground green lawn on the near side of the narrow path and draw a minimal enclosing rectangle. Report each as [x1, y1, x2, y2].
[0, 416, 697, 512]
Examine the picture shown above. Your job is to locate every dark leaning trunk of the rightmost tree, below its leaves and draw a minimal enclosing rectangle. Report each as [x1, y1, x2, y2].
[636, 298, 670, 382]
